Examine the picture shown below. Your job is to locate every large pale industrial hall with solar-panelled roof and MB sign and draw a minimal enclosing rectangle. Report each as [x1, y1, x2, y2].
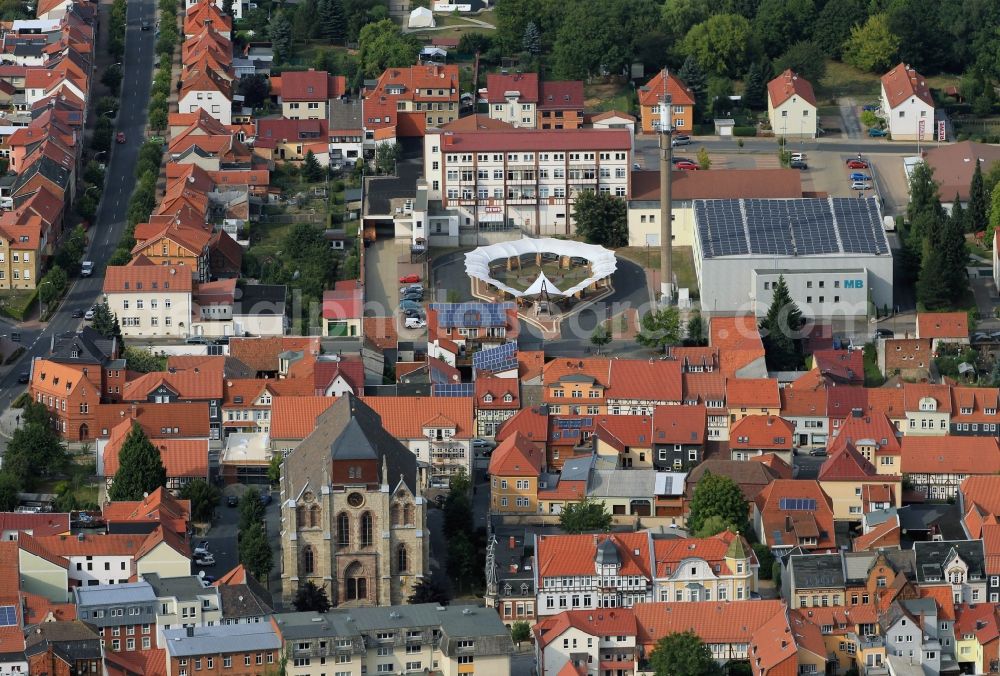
[693, 197, 893, 330]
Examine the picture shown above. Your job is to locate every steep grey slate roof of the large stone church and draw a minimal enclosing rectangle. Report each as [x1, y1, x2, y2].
[285, 394, 417, 495]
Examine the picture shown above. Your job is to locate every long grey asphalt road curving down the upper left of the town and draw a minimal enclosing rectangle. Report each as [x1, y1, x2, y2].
[0, 0, 156, 409]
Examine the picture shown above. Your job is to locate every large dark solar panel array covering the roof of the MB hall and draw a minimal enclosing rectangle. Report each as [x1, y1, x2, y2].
[694, 197, 889, 258]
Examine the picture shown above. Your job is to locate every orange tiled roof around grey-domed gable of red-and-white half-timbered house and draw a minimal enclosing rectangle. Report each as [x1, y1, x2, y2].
[537, 531, 652, 580]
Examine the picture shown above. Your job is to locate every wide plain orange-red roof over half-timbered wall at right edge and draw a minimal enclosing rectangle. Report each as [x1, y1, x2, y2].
[902, 436, 1000, 474]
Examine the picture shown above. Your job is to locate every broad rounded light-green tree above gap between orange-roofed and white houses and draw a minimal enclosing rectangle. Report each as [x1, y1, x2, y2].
[681, 14, 757, 77]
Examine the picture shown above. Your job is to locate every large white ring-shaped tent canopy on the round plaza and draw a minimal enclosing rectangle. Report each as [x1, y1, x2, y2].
[465, 237, 618, 297]
